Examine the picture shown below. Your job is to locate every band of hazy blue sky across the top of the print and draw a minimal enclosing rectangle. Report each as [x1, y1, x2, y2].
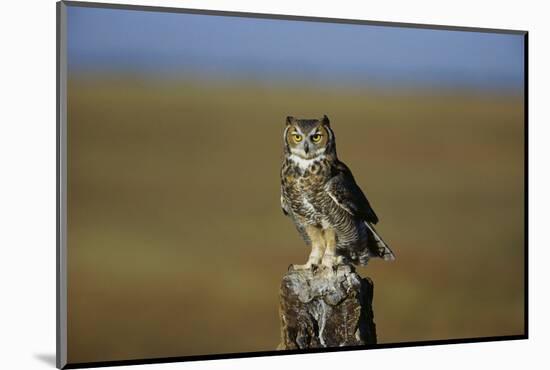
[68, 6, 523, 89]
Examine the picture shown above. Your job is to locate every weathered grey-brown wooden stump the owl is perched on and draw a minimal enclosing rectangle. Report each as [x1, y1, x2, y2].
[277, 265, 376, 350]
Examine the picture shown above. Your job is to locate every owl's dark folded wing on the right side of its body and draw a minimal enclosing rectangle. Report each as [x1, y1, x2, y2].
[325, 163, 378, 224]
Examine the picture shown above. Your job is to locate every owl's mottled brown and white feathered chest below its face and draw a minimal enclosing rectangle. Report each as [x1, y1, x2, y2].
[281, 158, 332, 224]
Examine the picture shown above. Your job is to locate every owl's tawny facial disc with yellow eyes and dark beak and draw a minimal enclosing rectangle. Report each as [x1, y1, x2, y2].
[286, 125, 328, 159]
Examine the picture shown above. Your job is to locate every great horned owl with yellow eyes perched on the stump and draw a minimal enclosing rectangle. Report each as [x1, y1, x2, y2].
[281, 115, 395, 269]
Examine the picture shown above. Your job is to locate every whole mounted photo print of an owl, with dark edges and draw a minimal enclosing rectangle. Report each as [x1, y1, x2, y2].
[57, 1, 527, 368]
